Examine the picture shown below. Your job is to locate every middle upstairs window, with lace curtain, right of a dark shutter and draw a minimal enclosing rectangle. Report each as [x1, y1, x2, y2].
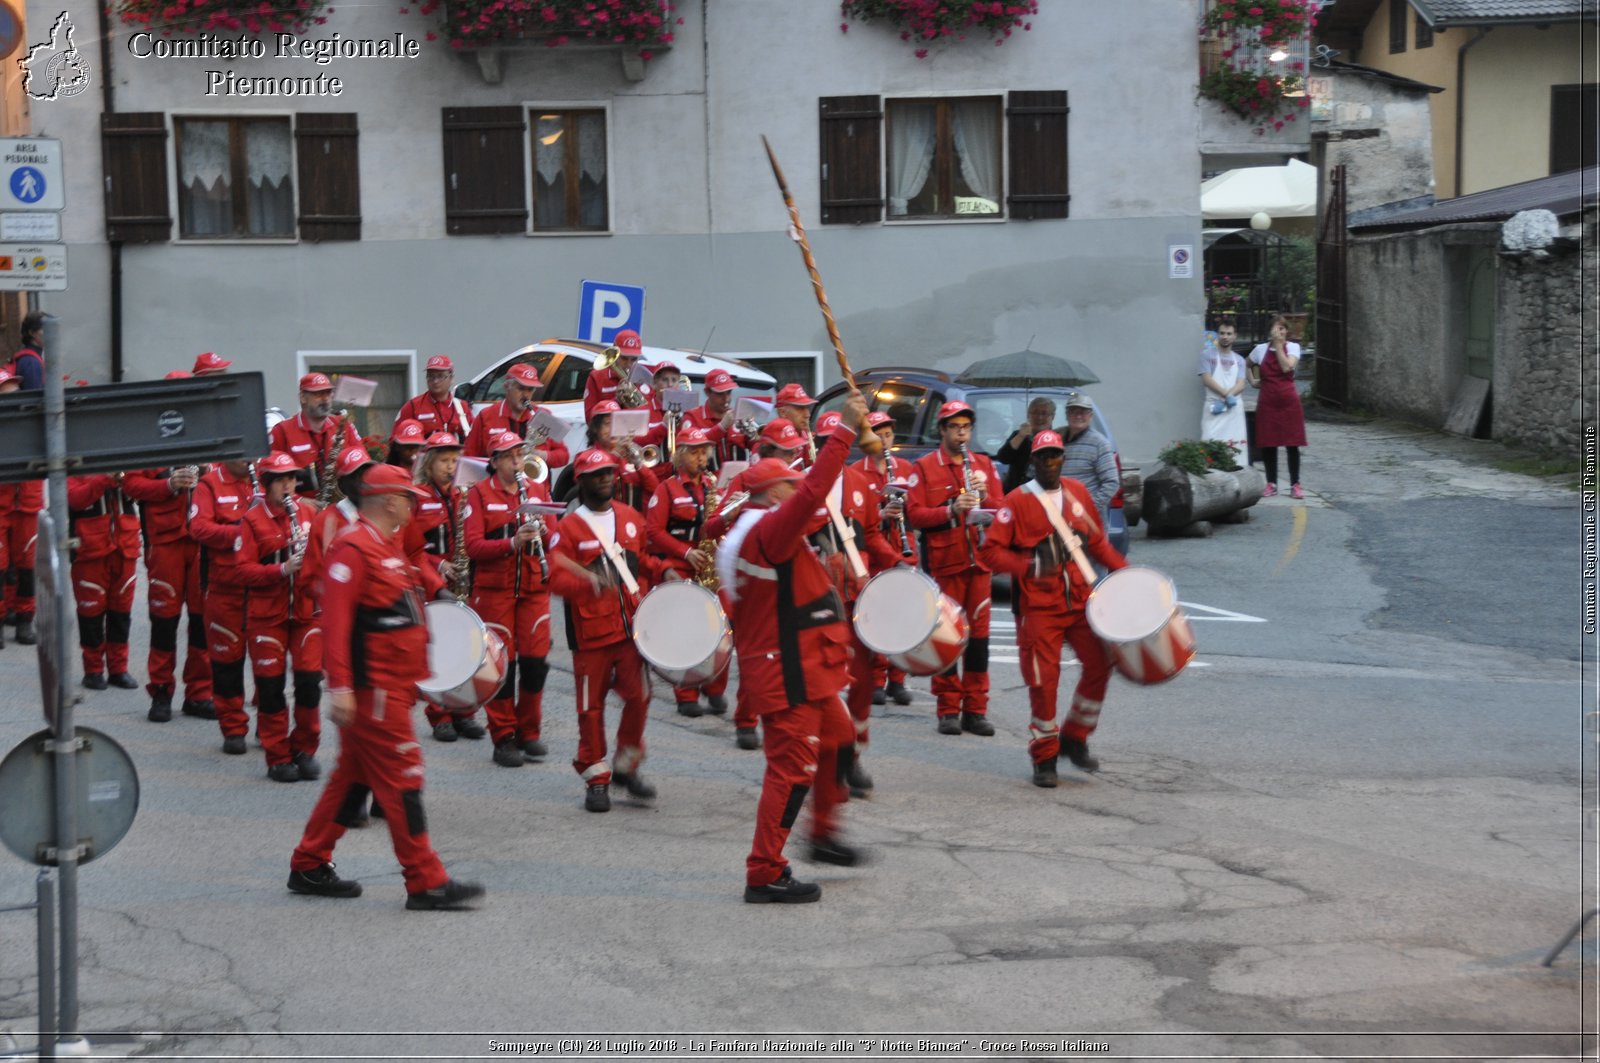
[528, 109, 611, 232]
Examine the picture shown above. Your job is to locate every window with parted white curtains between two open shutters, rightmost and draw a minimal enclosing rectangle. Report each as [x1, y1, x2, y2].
[883, 96, 1005, 221]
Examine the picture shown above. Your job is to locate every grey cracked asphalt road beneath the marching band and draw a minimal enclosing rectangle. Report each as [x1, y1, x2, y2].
[0, 423, 1595, 1058]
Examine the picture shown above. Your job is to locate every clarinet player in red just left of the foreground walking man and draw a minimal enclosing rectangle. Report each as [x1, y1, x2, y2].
[238, 451, 322, 783]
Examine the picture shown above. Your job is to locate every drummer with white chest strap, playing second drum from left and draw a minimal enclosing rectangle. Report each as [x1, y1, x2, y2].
[550, 448, 678, 812]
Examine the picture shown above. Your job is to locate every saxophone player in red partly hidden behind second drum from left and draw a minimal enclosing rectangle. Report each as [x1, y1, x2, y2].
[645, 427, 728, 717]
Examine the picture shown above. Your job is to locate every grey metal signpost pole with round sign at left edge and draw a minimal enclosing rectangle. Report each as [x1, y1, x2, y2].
[42, 314, 78, 1037]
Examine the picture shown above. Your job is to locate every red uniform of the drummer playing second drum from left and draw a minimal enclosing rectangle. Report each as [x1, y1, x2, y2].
[550, 503, 667, 784]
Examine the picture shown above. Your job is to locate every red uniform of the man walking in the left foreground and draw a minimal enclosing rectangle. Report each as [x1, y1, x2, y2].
[290, 520, 450, 893]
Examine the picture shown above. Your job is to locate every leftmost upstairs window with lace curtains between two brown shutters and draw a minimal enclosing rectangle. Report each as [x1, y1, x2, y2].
[173, 118, 294, 240]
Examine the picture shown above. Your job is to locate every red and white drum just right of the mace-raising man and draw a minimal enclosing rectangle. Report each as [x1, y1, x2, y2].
[856, 568, 970, 676]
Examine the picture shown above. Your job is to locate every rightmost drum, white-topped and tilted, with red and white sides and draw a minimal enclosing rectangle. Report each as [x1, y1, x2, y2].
[1086, 565, 1195, 687]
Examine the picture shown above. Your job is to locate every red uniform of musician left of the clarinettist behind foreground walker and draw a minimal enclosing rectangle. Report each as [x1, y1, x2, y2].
[189, 466, 253, 738]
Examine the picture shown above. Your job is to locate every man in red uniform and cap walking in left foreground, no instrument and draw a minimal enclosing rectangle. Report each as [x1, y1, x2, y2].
[288, 466, 483, 911]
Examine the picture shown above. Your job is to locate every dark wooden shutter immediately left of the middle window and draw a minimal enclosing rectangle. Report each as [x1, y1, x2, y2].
[445, 107, 528, 235]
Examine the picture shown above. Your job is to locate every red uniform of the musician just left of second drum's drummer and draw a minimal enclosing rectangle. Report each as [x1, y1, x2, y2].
[467, 475, 550, 746]
